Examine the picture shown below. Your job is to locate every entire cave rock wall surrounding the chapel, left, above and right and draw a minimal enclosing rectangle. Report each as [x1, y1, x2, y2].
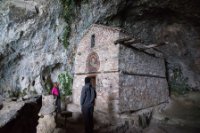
[0, 0, 200, 96]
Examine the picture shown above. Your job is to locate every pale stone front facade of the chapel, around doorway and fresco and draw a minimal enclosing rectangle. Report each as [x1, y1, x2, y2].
[73, 25, 120, 112]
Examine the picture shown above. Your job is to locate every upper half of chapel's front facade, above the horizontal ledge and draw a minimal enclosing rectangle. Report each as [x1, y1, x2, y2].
[75, 25, 119, 73]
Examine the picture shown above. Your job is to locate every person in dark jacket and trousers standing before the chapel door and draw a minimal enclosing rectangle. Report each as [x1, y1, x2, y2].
[80, 77, 96, 133]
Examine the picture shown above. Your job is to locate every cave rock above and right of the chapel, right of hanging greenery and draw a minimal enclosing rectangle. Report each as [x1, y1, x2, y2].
[70, 0, 200, 90]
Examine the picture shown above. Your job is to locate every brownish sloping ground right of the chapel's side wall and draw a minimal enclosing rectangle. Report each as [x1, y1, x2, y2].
[146, 92, 200, 133]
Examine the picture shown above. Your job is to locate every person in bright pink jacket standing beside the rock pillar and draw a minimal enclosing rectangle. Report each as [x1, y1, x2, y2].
[51, 82, 61, 112]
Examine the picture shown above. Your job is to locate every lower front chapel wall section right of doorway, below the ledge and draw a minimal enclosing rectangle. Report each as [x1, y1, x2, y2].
[95, 72, 119, 115]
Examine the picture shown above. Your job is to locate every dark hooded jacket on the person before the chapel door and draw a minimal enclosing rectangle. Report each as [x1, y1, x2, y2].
[80, 83, 96, 106]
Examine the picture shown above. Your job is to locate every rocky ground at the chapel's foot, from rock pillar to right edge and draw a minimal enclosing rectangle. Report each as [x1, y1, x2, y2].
[54, 93, 200, 133]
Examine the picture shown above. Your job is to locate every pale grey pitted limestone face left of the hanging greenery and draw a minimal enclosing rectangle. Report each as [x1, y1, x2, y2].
[0, 0, 66, 96]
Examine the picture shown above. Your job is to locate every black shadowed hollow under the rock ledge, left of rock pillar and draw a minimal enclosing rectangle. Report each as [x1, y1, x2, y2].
[0, 96, 42, 133]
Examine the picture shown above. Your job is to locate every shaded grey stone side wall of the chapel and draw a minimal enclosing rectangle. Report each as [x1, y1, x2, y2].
[119, 45, 169, 112]
